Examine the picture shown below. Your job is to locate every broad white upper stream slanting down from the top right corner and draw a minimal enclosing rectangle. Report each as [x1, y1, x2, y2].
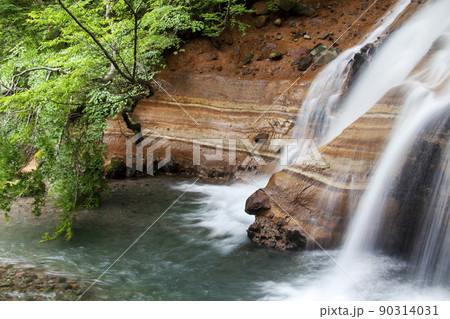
[322, 1, 450, 144]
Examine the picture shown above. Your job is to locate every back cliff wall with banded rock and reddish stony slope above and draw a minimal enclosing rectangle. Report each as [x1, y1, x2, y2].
[105, 0, 414, 179]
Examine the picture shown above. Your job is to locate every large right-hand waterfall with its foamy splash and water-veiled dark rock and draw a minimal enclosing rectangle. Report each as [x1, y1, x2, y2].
[261, 0, 450, 300]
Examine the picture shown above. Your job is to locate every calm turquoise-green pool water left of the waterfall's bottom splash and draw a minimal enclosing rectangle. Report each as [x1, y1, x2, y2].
[0, 178, 330, 300]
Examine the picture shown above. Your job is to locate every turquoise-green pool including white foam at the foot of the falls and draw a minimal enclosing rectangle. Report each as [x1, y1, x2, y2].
[0, 177, 450, 300]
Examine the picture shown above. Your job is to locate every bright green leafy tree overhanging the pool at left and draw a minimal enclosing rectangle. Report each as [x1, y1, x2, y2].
[0, 0, 246, 239]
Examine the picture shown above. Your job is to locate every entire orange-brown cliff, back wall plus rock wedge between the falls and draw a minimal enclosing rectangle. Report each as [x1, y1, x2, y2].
[105, 0, 419, 249]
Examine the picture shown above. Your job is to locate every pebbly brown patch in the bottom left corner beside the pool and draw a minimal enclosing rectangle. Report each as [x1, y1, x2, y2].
[0, 263, 92, 301]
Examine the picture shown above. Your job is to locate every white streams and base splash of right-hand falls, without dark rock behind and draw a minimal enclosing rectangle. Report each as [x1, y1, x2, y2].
[259, 0, 450, 300]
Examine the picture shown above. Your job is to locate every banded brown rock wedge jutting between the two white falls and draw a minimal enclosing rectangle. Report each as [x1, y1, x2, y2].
[246, 91, 401, 250]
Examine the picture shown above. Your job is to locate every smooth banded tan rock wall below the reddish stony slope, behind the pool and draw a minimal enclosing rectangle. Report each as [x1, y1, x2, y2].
[105, 73, 307, 178]
